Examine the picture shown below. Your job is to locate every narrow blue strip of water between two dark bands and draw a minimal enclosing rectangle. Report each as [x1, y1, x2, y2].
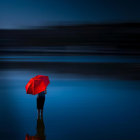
[0, 55, 140, 63]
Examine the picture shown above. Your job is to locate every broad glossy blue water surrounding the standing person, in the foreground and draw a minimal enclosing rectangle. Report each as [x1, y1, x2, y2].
[0, 69, 140, 140]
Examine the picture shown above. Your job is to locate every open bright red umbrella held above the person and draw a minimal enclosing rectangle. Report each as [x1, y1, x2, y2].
[25, 75, 50, 95]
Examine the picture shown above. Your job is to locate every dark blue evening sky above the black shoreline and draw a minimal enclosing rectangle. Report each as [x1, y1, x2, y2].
[0, 0, 140, 28]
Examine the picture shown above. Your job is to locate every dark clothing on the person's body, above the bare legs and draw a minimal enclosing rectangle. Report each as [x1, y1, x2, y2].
[37, 91, 45, 110]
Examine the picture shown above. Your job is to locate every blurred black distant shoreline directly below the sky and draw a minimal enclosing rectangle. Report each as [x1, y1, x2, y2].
[0, 23, 140, 54]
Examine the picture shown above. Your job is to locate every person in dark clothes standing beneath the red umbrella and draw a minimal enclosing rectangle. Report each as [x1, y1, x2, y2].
[37, 90, 47, 118]
